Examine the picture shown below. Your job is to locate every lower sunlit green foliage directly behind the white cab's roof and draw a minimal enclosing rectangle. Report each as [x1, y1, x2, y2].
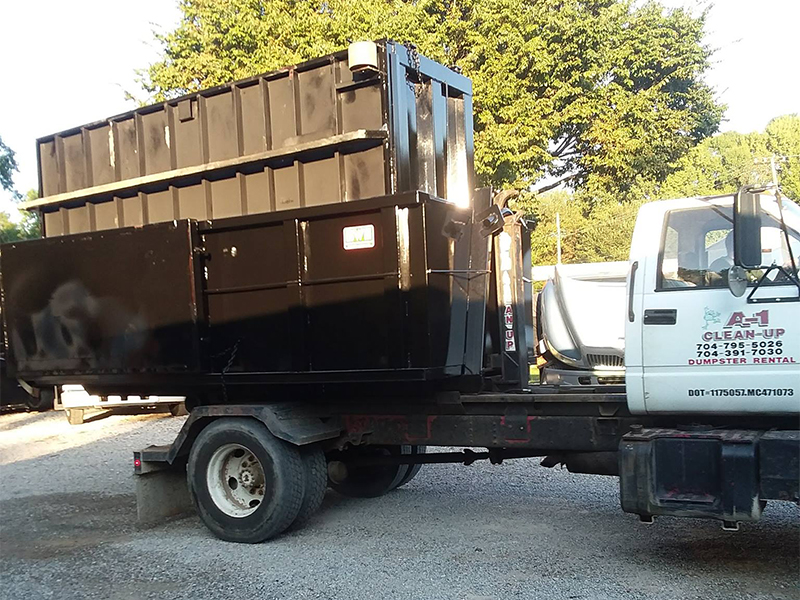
[519, 115, 800, 265]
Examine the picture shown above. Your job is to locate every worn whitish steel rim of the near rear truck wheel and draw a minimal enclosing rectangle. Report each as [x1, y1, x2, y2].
[206, 444, 266, 518]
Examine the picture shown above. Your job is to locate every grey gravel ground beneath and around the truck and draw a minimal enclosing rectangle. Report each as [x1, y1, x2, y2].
[0, 412, 800, 600]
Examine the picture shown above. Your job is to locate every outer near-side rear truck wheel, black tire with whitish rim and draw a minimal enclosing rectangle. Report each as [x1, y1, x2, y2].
[186, 417, 305, 544]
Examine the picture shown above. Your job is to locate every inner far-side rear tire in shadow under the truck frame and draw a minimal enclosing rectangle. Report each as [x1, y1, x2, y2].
[328, 446, 411, 498]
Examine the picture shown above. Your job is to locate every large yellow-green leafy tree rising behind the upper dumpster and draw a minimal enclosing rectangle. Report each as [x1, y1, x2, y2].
[141, 0, 723, 196]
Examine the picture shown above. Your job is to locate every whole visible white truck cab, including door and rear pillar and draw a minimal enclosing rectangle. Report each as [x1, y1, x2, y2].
[625, 190, 800, 415]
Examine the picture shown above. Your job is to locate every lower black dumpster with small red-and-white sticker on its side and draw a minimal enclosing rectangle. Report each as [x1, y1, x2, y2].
[0, 192, 488, 395]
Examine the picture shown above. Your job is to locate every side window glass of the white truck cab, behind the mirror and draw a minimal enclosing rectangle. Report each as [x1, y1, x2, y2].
[657, 206, 800, 290]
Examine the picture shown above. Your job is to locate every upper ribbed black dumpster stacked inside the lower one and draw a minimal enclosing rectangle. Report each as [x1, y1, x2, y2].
[29, 42, 474, 237]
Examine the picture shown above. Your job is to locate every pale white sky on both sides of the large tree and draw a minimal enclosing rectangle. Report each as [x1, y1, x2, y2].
[0, 0, 800, 216]
